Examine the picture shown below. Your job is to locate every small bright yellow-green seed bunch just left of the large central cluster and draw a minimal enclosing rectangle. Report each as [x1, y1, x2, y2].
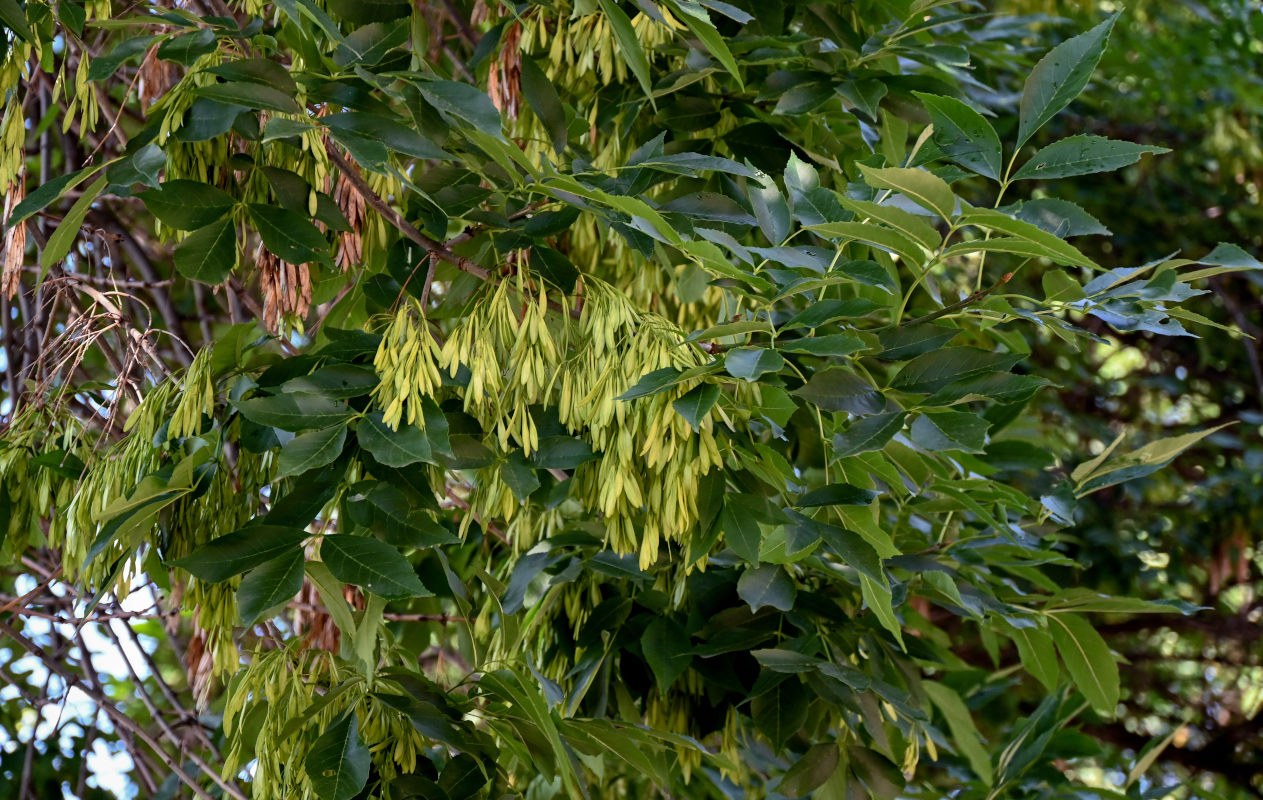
[373, 296, 442, 430]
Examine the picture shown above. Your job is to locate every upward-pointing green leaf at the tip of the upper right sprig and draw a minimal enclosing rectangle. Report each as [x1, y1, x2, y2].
[1017, 11, 1119, 148]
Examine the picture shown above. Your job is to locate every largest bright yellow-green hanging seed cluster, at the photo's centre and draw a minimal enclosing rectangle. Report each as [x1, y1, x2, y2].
[429, 273, 737, 566]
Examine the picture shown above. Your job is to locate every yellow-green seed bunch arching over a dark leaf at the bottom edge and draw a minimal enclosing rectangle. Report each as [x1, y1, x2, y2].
[222, 646, 427, 800]
